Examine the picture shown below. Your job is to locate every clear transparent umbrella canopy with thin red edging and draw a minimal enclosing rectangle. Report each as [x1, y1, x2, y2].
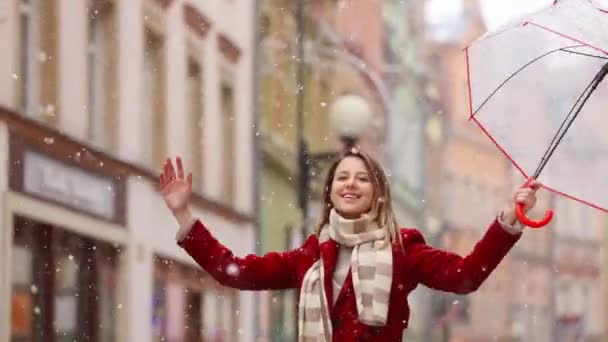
[465, 0, 608, 226]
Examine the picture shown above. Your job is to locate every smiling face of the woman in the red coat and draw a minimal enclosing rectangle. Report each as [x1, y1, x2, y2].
[330, 156, 374, 219]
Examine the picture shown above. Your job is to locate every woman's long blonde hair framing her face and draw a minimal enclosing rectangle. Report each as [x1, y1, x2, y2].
[315, 148, 401, 245]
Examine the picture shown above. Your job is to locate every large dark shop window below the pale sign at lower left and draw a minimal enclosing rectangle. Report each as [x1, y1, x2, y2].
[11, 218, 118, 342]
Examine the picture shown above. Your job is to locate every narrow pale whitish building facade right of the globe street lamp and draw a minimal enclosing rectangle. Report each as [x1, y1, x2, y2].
[382, 1, 434, 341]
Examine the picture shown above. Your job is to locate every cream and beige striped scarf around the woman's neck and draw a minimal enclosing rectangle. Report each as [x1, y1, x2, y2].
[298, 210, 393, 342]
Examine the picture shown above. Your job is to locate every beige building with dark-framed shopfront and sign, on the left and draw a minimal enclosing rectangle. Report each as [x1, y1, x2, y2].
[0, 0, 256, 341]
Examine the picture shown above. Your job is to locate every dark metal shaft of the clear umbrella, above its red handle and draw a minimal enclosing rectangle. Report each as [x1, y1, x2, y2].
[534, 63, 608, 178]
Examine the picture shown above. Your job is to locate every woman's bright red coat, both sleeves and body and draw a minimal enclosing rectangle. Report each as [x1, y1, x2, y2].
[179, 220, 521, 342]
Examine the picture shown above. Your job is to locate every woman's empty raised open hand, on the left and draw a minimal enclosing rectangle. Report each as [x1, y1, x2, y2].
[160, 156, 192, 225]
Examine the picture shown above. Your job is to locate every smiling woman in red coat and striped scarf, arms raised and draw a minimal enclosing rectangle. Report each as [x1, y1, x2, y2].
[160, 150, 540, 342]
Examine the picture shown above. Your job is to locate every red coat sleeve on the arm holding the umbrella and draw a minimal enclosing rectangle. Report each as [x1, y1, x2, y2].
[401, 220, 521, 294]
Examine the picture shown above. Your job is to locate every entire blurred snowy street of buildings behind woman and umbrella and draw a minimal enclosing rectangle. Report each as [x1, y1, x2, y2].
[0, 0, 608, 342]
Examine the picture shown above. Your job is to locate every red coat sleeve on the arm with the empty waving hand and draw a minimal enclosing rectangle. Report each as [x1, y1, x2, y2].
[178, 220, 318, 290]
